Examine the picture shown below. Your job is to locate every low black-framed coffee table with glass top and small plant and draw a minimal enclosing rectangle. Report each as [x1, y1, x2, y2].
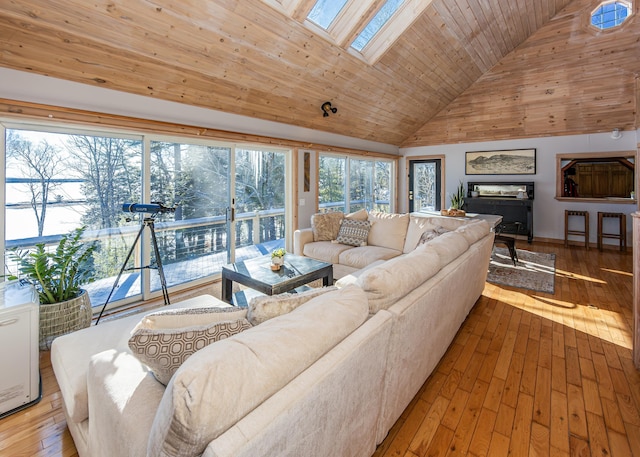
[222, 254, 333, 303]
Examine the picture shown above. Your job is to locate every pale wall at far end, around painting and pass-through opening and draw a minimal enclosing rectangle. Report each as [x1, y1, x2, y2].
[399, 130, 640, 245]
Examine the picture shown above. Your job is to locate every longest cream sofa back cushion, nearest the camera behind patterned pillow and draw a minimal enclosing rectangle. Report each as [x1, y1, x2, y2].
[147, 286, 368, 456]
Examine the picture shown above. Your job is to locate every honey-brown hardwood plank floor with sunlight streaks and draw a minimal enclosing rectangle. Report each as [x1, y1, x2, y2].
[0, 242, 640, 457]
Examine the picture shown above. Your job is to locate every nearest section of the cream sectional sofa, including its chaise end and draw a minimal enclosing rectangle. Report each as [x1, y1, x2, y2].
[54, 286, 391, 457]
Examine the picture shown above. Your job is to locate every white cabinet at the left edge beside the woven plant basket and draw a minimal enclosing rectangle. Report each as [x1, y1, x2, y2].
[0, 281, 42, 418]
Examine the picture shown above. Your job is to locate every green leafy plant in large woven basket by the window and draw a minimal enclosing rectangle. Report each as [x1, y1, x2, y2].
[9, 227, 96, 350]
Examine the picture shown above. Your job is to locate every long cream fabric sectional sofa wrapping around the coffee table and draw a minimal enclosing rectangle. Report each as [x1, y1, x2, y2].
[51, 211, 493, 457]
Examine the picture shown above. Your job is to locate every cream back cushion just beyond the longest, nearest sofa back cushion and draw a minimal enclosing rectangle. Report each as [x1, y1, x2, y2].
[355, 244, 441, 314]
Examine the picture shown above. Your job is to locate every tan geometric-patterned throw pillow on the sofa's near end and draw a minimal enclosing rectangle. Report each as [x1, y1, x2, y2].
[129, 318, 251, 385]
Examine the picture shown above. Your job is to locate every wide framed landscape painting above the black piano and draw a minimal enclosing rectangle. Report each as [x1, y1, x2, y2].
[465, 149, 536, 175]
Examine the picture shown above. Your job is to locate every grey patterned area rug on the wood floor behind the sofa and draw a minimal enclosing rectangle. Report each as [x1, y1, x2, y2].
[487, 247, 556, 294]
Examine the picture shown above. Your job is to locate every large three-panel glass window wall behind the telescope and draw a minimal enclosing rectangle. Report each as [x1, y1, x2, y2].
[1, 124, 290, 308]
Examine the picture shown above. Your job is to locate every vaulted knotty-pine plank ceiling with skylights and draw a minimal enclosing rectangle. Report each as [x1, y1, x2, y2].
[0, 0, 640, 146]
